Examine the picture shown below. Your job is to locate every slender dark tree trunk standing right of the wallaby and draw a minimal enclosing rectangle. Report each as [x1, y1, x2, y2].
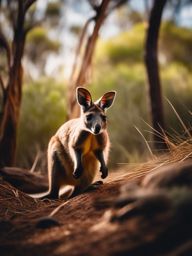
[145, 0, 166, 149]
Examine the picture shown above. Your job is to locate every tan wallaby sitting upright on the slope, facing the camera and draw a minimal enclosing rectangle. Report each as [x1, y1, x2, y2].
[32, 87, 116, 198]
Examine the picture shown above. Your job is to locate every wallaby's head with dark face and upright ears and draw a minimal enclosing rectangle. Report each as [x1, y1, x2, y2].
[76, 87, 116, 135]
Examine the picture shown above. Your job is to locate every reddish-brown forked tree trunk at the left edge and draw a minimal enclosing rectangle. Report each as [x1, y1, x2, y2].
[0, 0, 36, 167]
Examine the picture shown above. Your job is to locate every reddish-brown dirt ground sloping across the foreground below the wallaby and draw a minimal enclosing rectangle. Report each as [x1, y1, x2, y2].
[0, 159, 192, 256]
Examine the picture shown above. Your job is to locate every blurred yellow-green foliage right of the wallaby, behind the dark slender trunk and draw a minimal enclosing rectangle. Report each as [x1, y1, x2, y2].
[91, 21, 192, 167]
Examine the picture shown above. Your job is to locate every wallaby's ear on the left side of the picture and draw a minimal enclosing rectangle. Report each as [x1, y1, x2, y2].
[76, 87, 92, 110]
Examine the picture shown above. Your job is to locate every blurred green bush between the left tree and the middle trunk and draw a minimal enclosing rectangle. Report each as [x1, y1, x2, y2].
[17, 79, 66, 167]
